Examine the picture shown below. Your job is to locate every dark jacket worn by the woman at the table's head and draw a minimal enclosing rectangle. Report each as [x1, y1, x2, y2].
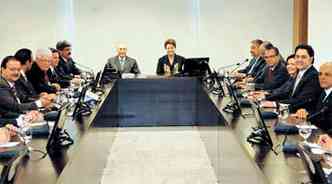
[156, 54, 186, 75]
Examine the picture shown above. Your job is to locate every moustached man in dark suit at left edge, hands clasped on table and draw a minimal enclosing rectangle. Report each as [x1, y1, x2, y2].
[0, 56, 51, 118]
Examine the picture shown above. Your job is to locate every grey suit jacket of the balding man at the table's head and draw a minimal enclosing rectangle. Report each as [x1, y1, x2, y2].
[105, 56, 141, 74]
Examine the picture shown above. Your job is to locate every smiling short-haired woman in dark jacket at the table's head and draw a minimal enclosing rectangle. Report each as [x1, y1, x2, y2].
[157, 39, 185, 75]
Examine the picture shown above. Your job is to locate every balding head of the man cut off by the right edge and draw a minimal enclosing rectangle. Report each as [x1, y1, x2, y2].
[319, 61, 332, 89]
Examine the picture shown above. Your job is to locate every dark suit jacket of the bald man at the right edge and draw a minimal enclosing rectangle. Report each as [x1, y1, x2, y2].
[309, 93, 332, 131]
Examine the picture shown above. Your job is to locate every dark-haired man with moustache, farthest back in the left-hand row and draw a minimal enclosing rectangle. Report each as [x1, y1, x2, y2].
[56, 40, 81, 80]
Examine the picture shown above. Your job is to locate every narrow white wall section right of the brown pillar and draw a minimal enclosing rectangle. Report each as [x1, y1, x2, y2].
[309, 0, 332, 66]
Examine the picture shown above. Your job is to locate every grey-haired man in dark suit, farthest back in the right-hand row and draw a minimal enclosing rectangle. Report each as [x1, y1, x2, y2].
[238, 39, 265, 77]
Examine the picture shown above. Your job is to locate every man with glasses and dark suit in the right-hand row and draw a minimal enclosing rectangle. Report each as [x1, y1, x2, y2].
[254, 45, 289, 90]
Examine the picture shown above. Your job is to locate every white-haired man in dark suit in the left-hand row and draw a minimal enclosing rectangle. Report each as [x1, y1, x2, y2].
[27, 49, 61, 93]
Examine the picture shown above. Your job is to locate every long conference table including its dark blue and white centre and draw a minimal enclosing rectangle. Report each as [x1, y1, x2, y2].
[1, 77, 308, 184]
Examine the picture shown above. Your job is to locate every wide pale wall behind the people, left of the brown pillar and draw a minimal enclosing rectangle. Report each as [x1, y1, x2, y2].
[0, 0, 293, 74]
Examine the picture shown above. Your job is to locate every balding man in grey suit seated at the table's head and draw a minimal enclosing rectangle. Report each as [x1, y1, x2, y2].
[105, 44, 141, 74]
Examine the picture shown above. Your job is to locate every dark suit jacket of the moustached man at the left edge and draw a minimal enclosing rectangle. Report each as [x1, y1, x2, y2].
[0, 77, 38, 118]
